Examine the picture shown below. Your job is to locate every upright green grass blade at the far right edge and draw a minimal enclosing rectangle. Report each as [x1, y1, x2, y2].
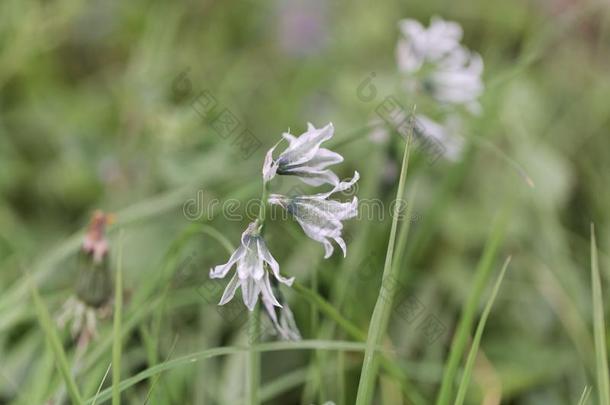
[591, 224, 610, 405]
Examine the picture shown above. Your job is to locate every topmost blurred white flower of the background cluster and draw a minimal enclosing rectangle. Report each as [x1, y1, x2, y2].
[396, 17, 462, 73]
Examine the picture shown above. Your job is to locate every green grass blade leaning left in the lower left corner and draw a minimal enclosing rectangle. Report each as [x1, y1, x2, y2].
[29, 279, 83, 405]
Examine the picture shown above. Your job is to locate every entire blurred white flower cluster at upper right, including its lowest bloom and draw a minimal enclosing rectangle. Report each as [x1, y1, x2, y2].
[396, 17, 484, 159]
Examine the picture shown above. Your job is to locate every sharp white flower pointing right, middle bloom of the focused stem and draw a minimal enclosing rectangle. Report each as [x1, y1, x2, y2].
[269, 172, 360, 258]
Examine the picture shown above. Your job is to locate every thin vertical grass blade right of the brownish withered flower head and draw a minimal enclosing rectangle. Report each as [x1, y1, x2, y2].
[112, 230, 123, 405]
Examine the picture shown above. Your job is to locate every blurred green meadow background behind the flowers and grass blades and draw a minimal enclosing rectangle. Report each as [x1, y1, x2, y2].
[0, 0, 610, 404]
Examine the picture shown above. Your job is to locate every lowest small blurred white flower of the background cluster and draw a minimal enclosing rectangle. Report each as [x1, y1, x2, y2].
[414, 114, 463, 160]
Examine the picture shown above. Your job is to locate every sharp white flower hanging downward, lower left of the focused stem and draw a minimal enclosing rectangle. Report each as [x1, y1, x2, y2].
[210, 222, 294, 311]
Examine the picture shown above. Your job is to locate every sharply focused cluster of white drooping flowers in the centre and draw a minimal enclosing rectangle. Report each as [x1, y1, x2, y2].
[210, 124, 359, 340]
